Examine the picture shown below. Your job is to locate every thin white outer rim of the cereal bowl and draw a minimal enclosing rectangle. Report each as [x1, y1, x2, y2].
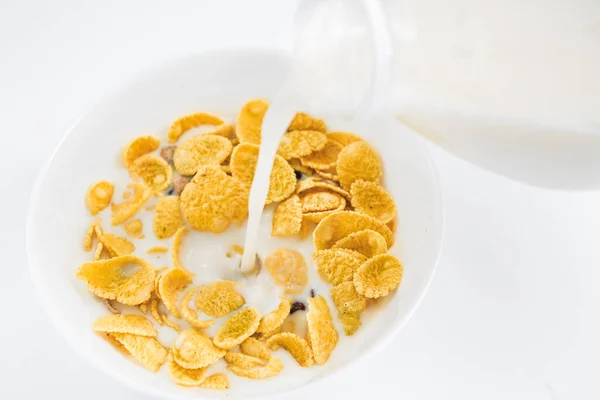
[25, 46, 446, 400]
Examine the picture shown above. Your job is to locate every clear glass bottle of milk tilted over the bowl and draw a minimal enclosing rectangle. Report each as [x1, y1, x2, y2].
[291, 0, 600, 190]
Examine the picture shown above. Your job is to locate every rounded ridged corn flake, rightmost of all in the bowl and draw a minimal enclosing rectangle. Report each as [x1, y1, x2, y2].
[354, 253, 404, 299]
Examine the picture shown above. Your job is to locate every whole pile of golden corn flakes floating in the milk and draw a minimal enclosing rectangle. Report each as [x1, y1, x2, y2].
[77, 99, 403, 389]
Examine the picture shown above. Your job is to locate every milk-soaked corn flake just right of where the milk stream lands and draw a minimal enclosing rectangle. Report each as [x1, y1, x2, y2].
[265, 248, 308, 294]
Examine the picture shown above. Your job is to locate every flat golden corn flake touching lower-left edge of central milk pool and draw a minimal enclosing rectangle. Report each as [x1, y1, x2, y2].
[196, 281, 246, 318]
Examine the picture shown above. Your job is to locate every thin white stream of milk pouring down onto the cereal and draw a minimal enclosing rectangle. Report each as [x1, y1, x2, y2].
[241, 98, 296, 273]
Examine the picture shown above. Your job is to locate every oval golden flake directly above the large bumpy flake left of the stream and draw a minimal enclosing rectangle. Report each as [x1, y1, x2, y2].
[173, 134, 233, 176]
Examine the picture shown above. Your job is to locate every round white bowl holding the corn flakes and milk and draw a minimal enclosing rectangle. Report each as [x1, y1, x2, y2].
[27, 50, 443, 399]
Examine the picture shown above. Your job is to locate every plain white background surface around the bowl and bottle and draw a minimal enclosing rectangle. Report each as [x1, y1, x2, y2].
[0, 0, 600, 400]
